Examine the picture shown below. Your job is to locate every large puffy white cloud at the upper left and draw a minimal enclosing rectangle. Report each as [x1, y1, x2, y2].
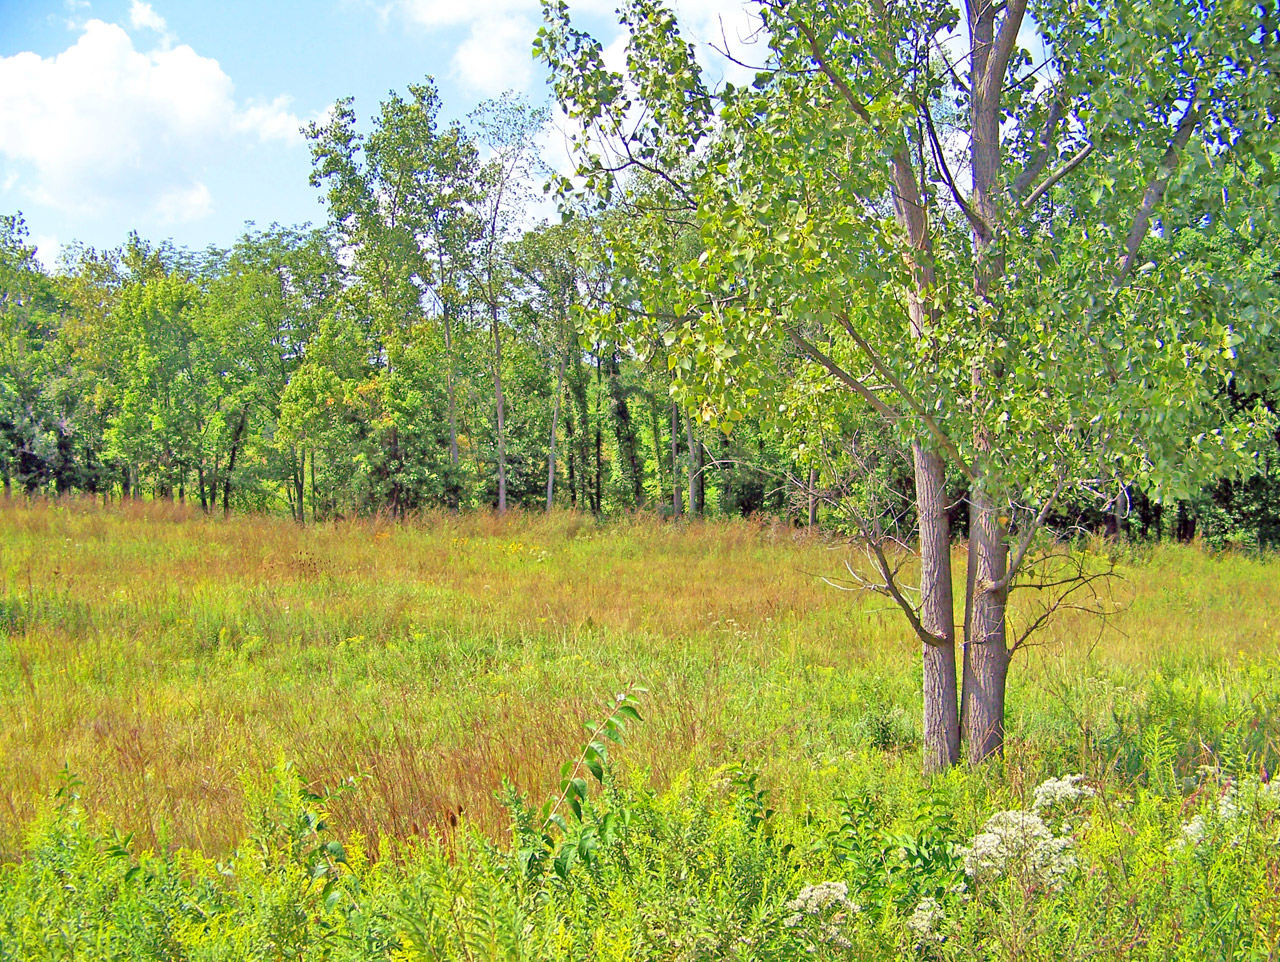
[0, 15, 302, 221]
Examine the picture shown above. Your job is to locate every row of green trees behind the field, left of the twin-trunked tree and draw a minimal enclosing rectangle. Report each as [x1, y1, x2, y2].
[0, 90, 787, 521]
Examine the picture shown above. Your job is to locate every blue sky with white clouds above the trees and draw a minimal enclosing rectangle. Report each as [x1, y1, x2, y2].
[0, 0, 751, 266]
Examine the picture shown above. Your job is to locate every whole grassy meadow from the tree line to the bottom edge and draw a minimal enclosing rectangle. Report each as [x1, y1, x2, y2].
[0, 500, 1280, 958]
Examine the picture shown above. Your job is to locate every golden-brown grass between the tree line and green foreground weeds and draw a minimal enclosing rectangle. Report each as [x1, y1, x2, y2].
[0, 500, 1280, 852]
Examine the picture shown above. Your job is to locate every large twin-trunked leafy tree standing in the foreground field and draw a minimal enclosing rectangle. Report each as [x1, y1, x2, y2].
[535, 0, 1280, 769]
